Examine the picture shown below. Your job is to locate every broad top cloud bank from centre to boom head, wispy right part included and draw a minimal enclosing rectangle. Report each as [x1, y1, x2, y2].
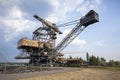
[46, 0, 101, 23]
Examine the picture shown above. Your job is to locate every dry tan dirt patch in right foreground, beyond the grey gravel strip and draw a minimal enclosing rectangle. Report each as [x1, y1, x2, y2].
[20, 69, 120, 80]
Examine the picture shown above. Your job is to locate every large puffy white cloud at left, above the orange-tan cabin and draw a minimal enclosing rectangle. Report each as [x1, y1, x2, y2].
[1, 6, 35, 41]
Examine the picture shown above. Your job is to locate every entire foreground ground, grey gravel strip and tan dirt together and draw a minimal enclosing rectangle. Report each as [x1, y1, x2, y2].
[0, 68, 120, 80]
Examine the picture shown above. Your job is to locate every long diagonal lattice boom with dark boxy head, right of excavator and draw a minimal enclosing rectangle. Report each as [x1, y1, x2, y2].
[54, 10, 99, 54]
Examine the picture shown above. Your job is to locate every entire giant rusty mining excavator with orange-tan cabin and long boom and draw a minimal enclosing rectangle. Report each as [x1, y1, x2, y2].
[15, 10, 99, 66]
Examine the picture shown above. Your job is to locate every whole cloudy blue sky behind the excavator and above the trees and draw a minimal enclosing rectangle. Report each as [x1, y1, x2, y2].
[0, 0, 120, 62]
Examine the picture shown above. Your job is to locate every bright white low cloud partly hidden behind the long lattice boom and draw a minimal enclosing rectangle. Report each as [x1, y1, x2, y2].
[56, 29, 86, 47]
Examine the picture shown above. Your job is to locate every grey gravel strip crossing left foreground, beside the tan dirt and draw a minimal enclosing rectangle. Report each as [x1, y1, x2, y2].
[0, 68, 81, 80]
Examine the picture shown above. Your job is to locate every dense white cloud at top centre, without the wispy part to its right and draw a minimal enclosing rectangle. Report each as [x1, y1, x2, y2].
[46, 0, 84, 22]
